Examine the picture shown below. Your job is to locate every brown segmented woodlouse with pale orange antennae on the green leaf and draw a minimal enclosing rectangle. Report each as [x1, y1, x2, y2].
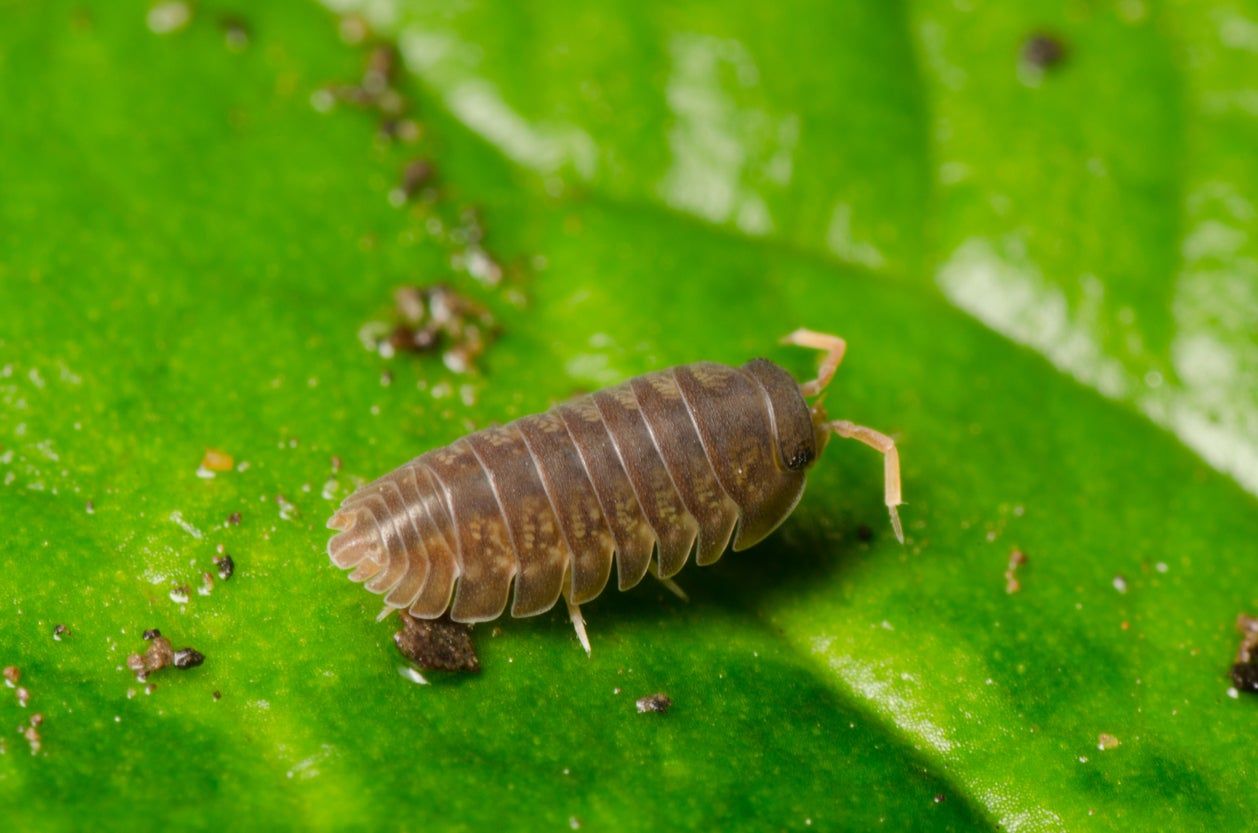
[327, 330, 905, 653]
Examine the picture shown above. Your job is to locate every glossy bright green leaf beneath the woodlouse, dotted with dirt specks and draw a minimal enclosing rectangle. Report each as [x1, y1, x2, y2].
[0, 1, 1258, 830]
